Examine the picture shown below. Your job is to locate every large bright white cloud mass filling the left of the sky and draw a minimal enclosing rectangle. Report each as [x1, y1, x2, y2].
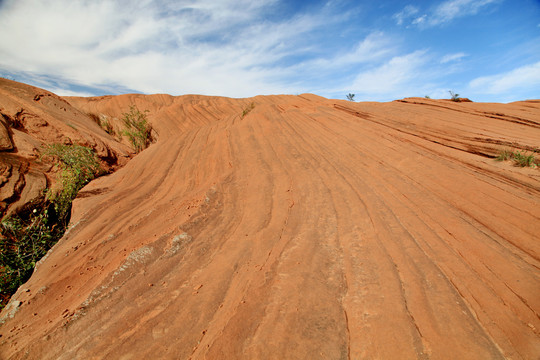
[0, 0, 339, 96]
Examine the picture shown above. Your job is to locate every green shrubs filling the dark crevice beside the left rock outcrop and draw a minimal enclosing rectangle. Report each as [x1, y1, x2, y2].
[0, 144, 101, 309]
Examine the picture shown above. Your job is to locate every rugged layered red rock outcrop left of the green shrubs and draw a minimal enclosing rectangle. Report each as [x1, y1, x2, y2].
[0, 78, 131, 217]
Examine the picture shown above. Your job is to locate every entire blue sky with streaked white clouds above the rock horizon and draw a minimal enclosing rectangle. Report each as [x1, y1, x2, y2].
[0, 0, 540, 102]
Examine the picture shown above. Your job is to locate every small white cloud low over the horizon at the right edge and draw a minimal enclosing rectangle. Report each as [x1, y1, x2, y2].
[469, 61, 540, 95]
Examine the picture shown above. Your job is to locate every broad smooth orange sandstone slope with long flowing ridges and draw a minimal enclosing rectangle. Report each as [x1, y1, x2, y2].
[0, 80, 540, 359]
